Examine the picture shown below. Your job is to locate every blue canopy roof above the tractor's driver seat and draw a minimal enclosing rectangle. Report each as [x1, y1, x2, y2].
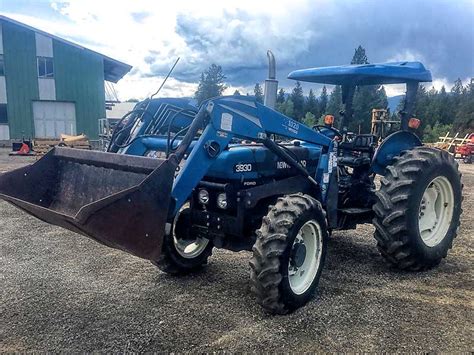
[288, 62, 431, 85]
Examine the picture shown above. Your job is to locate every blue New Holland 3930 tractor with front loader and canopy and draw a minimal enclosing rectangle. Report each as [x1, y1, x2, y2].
[0, 53, 462, 314]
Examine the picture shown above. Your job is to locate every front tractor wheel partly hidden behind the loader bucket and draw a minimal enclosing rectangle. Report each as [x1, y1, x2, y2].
[153, 208, 213, 275]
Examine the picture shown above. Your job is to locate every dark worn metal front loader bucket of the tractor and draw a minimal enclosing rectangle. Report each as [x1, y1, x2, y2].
[0, 147, 178, 260]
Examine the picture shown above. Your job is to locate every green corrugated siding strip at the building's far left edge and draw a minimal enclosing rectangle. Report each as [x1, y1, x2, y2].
[2, 22, 38, 138]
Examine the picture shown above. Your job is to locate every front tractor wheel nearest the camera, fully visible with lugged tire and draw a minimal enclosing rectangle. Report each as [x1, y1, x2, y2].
[250, 194, 328, 314]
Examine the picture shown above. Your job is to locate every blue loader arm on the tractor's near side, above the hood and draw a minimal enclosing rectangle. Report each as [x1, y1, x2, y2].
[170, 96, 337, 216]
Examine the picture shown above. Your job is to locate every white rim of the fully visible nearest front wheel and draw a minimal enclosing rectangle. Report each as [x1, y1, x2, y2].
[288, 220, 323, 295]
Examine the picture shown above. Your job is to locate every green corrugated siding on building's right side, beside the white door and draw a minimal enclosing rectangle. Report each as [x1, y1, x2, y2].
[53, 40, 105, 139]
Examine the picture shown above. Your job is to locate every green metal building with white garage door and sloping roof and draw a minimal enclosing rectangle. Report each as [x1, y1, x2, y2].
[0, 16, 131, 140]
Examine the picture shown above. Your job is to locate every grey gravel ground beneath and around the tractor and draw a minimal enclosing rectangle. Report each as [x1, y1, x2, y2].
[0, 150, 474, 352]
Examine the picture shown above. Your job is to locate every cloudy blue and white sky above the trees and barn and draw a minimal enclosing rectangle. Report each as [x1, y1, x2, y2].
[0, 0, 474, 100]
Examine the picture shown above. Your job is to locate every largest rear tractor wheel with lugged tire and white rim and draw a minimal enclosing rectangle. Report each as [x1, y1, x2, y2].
[373, 147, 462, 271]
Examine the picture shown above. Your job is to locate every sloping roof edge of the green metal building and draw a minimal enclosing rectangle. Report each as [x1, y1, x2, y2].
[0, 15, 132, 83]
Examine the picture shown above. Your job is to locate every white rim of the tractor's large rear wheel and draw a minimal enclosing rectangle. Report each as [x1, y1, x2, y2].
[418, 176, 454, 247]
